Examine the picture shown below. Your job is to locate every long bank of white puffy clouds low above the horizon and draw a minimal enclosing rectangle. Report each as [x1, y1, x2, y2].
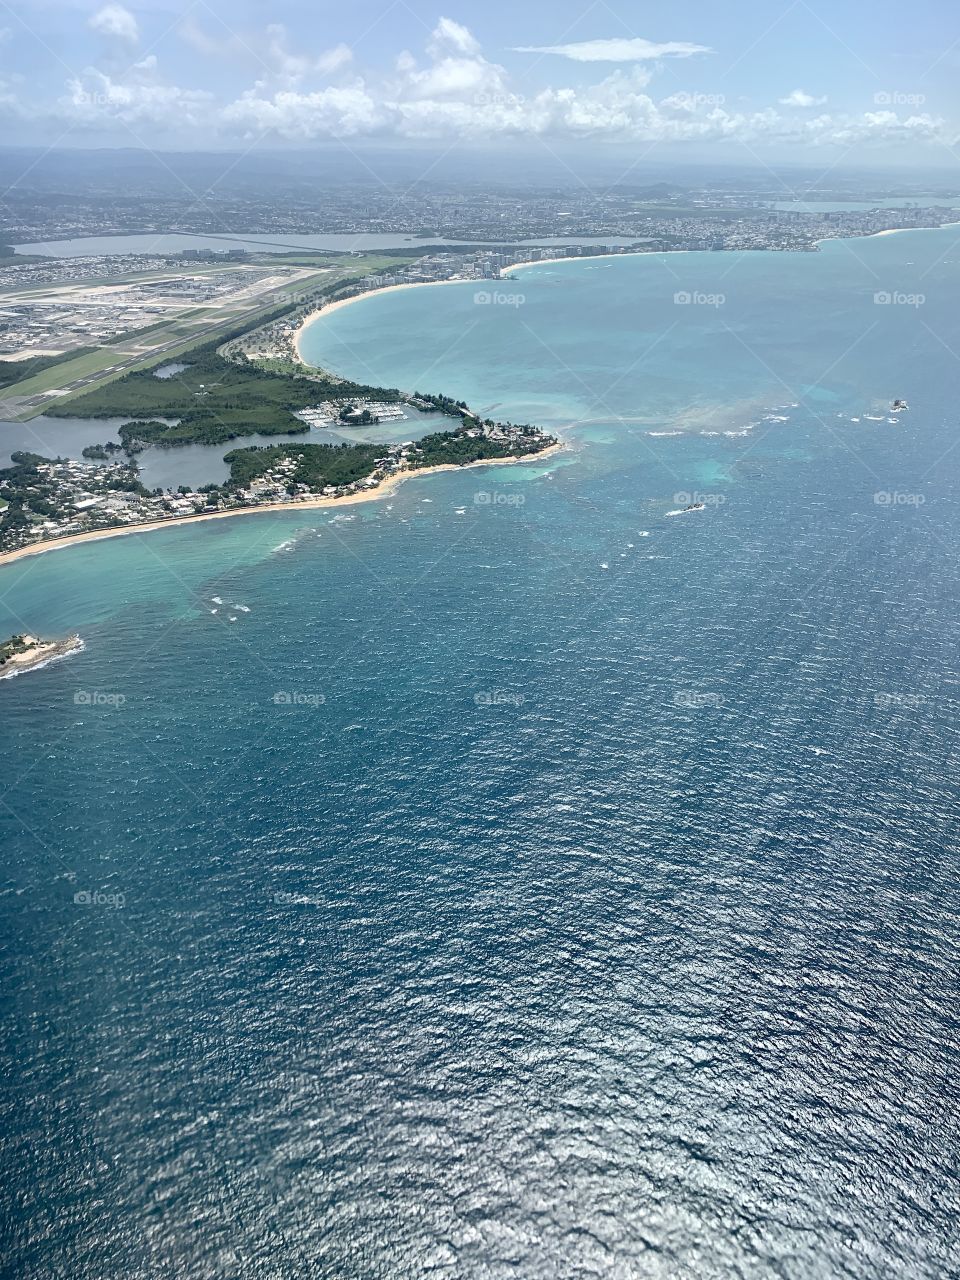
[59, 18, 952, 150]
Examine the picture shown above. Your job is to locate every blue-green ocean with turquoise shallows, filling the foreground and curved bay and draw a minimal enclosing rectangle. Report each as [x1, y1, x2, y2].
[0, 229, 960, 1280]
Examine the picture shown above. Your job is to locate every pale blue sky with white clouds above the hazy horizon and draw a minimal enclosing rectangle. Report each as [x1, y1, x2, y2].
[0, 0, 960, 168]
